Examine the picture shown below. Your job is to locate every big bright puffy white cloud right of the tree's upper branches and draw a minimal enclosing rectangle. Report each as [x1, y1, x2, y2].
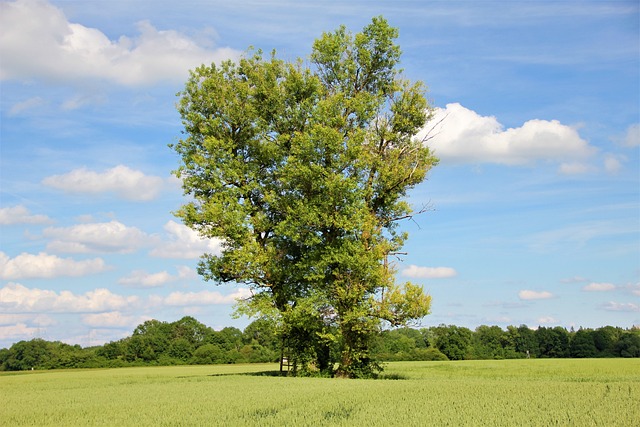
[418, 103, 596, 166]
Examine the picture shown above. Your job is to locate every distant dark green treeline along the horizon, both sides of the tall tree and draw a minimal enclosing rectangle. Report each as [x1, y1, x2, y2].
[0, 316, 640, 371]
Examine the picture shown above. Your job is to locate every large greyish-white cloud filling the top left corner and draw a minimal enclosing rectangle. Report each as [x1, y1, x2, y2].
[0, 0, 239, 85]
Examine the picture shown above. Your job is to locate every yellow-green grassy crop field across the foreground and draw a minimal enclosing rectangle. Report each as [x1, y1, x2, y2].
[0, 359, 640, 427]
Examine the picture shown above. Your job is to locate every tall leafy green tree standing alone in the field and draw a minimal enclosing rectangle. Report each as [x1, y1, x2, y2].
[172, 17, 437, 377]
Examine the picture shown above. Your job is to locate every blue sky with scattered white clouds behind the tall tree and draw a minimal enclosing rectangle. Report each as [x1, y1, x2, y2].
[0, 0, 640, 348]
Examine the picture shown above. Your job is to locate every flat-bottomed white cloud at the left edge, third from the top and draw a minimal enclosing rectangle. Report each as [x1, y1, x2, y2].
[0, 252, 107, 280]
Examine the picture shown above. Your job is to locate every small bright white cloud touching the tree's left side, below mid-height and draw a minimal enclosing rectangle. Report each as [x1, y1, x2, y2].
[151, 221, 222, 259]
